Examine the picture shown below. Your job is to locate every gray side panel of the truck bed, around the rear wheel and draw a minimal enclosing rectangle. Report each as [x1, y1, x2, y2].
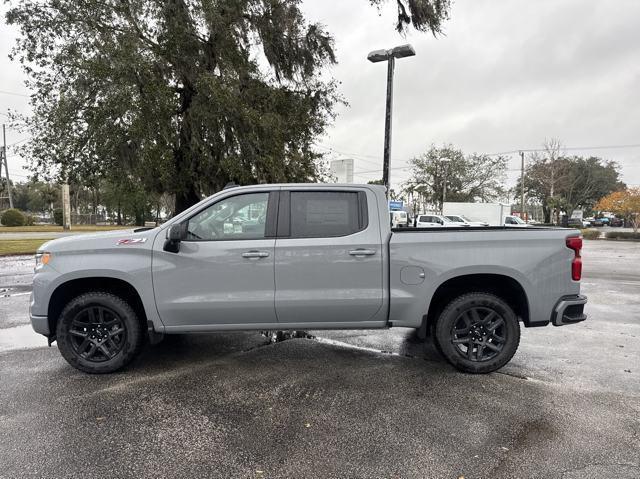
[389, 226, 580, 326]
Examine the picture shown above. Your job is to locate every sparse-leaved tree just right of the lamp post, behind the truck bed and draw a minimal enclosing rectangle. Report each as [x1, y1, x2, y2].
[403, 145, 508, 214]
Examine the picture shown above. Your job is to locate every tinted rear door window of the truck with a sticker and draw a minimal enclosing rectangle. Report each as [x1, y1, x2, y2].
[291, 191, 367, 238]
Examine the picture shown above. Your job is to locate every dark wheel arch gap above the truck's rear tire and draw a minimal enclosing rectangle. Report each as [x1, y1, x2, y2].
[423, 273, 530, 335]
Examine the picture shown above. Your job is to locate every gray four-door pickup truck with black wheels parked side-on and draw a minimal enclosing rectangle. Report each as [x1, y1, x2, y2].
[30, 184, 586, 373]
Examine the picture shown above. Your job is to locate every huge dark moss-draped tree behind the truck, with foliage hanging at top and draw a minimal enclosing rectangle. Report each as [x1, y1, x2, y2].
[6, 0, 449, 211]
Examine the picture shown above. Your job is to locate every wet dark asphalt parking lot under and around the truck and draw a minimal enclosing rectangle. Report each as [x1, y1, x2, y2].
[0, 241, 640, 478]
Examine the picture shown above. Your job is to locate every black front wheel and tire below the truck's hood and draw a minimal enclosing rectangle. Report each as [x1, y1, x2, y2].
[56, 291, 144, 374]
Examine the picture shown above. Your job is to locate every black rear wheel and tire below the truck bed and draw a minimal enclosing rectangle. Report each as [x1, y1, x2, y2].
[434, 292, 520, 374]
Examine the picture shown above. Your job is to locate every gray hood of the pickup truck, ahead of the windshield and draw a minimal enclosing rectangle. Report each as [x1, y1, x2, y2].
[38, 228, 159, 253]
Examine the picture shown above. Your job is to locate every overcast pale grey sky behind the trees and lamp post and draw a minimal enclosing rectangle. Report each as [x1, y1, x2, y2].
[0, 0, 640, 191]
